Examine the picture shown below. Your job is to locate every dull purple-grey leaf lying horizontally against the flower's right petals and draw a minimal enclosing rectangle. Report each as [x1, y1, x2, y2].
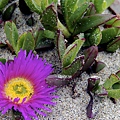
[46, 75, 72, 87]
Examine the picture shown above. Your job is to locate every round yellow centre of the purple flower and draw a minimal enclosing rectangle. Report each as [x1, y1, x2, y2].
[4, 77, 34, 103]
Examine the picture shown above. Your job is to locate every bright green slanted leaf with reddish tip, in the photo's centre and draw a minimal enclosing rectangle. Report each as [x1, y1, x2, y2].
[62, 39, 85, 67]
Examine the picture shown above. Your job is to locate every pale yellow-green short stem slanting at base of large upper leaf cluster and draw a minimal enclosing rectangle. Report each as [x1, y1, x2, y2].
[57, 19, 71, 38]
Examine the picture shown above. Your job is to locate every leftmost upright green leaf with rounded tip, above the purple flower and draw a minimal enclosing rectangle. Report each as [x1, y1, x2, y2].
[4, 21, 18, 51]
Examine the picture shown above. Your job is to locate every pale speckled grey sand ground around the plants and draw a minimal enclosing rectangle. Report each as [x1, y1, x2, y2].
[0, 1, 120, 120]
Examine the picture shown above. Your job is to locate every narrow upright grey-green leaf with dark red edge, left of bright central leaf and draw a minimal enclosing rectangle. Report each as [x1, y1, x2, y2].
[56, 30, 66, 60]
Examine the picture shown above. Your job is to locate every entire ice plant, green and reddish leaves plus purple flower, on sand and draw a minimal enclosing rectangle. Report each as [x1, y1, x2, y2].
[0, 0, 120, 120]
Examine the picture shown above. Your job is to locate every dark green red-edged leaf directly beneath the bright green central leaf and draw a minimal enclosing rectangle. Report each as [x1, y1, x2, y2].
[62, 56, 84, 75]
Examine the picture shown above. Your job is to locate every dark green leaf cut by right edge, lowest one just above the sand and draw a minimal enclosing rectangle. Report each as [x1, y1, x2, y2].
[106, 37, 120, 52]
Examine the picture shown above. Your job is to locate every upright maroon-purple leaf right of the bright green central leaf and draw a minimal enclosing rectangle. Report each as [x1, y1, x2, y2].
[82, 46, 98, 71]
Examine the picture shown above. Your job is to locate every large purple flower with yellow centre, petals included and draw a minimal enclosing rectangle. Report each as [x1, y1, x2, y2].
[0, 50, 56, 120]
